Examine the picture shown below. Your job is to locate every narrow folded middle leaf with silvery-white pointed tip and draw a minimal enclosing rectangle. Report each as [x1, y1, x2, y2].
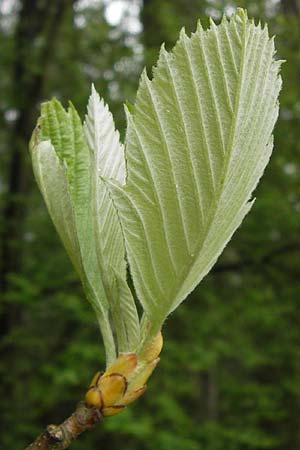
[84, 86, 139, 352]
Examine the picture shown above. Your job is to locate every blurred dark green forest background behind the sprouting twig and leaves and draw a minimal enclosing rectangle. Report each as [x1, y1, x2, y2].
[0, 0, 300, 450]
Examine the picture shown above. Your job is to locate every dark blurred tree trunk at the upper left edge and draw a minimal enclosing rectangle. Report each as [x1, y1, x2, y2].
[0, 0, 73, 293]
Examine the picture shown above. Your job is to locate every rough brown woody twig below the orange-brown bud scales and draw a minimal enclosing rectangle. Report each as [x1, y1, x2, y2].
[25, 402, 102, 450]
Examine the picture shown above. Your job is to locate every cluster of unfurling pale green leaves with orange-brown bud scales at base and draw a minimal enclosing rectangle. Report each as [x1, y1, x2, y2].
[31, 9, 281, 380]
